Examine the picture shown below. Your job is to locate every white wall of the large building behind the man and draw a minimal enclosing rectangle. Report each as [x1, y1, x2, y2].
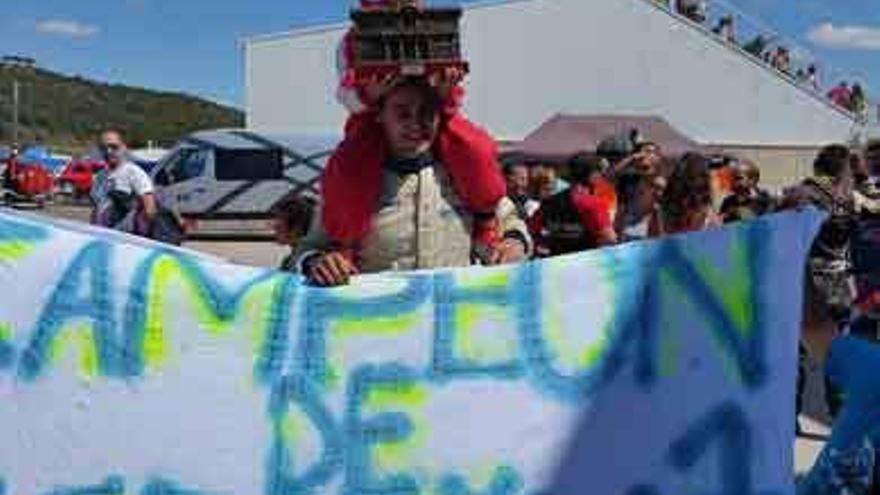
[246, 0, 853, 146]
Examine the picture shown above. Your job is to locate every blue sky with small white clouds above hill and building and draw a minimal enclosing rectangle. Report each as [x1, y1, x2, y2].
[0, 0, 880, 107]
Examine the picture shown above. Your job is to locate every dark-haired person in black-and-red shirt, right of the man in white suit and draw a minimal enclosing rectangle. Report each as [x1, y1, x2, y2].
[529, 154, 617, 256]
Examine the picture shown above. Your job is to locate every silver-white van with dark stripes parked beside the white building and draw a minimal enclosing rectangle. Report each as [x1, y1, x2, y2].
[151, 129, 341, 220]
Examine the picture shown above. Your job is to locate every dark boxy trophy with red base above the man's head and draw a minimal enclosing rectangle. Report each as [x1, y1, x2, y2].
[351, 0, 468, 81]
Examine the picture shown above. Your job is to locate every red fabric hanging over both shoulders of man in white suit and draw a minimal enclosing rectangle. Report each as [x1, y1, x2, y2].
[321, 112, 506, 248]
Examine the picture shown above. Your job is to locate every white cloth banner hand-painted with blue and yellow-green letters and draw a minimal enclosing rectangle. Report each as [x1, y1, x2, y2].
[0, 212, 819, 495]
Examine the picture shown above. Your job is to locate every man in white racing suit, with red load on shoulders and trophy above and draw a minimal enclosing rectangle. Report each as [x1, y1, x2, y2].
[298, 0, 531, 286]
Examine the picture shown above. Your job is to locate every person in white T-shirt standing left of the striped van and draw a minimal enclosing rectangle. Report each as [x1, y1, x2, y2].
[92, 130, 158, 230]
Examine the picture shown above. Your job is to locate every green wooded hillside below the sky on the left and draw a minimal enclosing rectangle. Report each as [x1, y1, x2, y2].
[0, 66, 244, 150]
